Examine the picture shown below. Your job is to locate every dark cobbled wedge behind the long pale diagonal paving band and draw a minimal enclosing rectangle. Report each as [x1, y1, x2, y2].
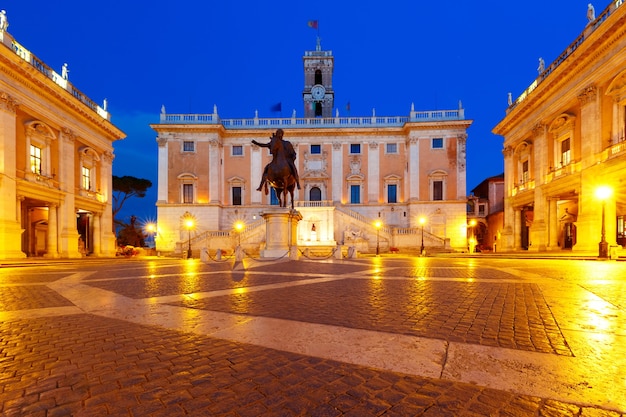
[174, 279, 572, 356]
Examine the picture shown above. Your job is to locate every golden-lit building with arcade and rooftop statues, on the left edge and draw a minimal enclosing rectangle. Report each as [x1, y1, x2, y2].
[0, 22, 124, 259]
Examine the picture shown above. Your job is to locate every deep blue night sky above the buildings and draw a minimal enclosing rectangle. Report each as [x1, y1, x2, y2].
[0, 0, 596, 221]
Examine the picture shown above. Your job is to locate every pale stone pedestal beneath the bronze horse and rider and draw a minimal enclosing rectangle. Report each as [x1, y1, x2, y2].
[261, 207, 302, 259]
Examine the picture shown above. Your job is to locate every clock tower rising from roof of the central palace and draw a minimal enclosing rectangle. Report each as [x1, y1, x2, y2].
[302, 36, 335, 118]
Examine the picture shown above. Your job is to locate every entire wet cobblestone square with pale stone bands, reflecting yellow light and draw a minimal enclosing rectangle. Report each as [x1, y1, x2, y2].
[0, 257, 626, 417]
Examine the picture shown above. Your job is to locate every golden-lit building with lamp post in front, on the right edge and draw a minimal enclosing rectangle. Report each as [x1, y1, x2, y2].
[493, 1, 626, 253]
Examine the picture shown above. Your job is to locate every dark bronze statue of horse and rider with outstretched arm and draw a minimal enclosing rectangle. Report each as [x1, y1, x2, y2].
[252, 129, 298, 210]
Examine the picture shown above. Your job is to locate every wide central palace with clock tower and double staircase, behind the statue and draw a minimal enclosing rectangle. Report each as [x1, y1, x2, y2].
[151, 40, 471, 256]
